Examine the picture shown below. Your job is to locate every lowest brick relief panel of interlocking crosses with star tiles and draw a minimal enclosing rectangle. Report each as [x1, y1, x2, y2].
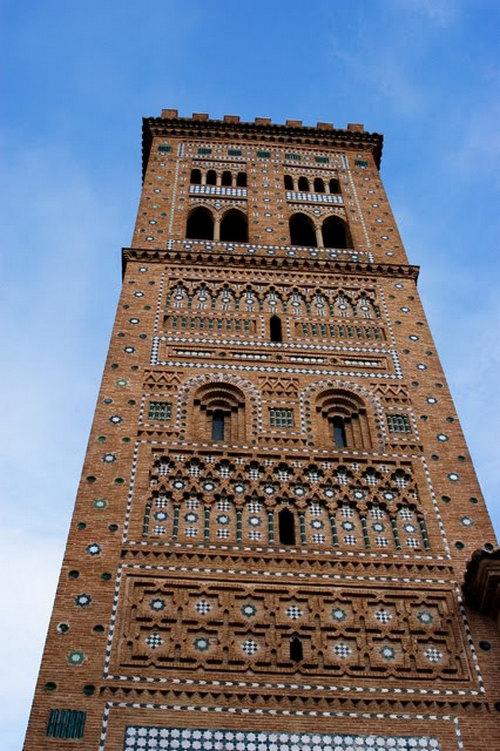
[112, 575, 471, 683]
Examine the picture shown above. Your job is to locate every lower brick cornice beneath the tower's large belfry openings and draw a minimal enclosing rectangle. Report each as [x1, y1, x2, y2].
[122, 248, 420, 280]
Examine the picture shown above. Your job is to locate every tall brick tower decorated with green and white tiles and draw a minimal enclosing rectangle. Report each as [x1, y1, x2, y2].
[25, 110, 500, 751]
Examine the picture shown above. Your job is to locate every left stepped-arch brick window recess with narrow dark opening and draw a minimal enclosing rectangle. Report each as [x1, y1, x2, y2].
[189, 382, 246, 443]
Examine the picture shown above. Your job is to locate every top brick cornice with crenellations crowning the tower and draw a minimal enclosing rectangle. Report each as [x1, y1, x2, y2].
[142, 115, 383, 179]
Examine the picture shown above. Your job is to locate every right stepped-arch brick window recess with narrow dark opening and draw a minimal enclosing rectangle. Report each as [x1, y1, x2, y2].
[316, 388, 372, 449]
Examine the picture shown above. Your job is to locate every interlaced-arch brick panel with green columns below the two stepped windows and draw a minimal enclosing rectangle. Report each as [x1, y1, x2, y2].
[135, 452, 430, 554]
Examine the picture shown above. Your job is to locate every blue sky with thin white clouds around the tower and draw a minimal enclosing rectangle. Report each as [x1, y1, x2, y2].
[0, 0, 500, 751]
